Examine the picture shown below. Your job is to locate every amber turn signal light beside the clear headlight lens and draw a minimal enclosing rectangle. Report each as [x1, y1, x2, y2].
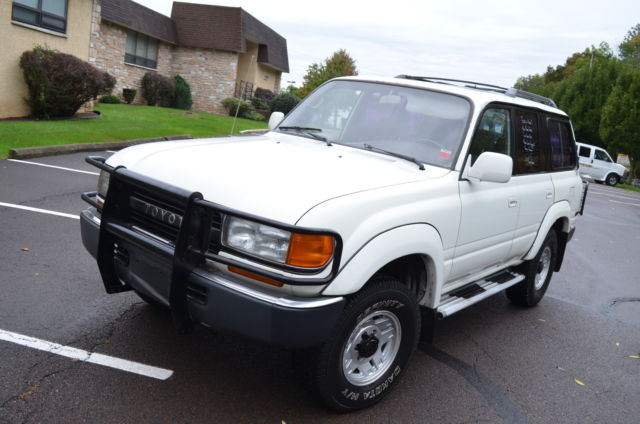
[286, 233, 334, 268]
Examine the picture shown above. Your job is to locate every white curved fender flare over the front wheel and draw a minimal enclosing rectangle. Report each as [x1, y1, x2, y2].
[322, 223, 444, 301]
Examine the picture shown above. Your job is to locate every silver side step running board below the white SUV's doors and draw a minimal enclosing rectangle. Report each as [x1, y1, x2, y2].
[436, 271, 524, 318]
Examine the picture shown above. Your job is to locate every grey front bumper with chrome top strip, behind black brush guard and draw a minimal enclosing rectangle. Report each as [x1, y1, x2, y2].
[80, 208, 345, 348]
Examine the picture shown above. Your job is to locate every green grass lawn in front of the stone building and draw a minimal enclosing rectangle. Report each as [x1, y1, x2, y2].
[0, 104, 267, 158]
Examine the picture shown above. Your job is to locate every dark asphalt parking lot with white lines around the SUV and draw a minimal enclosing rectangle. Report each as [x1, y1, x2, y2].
[0, 152, 640, 424]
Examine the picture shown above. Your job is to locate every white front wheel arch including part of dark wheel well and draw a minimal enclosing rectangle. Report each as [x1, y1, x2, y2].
[323, 224, 444, 306]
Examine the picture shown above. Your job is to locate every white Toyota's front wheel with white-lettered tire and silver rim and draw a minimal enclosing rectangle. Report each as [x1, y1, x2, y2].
[314, 277, 420, 412]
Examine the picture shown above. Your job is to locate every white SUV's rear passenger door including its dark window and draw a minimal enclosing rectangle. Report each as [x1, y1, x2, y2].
[510, 108, 555, 257]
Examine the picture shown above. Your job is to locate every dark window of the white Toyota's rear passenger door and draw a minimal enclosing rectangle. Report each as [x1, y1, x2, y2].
[513, 110, 545, 174]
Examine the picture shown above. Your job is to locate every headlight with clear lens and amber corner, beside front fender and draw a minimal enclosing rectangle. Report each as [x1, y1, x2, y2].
[222, 216, 334, 268]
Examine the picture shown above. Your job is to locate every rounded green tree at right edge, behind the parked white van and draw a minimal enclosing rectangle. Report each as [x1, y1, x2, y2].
[600, 66, 640, 177]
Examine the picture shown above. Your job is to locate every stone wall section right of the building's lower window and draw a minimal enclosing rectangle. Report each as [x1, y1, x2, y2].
[171, 47, 238, 114]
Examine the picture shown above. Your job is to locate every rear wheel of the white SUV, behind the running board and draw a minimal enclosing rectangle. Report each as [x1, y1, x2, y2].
[507, 230, 558, 306]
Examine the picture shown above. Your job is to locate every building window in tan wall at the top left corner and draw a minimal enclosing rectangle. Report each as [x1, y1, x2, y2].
[11, 0, 67, 33]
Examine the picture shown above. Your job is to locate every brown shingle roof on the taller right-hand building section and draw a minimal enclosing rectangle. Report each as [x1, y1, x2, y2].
[171, 2, 289, 72]
